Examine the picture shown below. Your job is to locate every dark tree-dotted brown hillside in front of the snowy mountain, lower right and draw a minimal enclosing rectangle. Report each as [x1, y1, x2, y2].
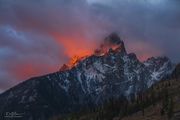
[52, 65, 180, 120]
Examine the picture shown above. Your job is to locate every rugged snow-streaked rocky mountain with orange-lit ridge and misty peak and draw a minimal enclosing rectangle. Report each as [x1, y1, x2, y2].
[0, 33, 174, 120]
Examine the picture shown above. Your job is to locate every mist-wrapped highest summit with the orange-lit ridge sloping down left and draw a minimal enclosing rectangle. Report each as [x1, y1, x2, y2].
[60, 33, 127, 71]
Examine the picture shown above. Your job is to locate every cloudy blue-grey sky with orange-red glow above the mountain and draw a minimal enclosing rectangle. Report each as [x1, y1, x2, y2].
[0, 0, 180, 92]
